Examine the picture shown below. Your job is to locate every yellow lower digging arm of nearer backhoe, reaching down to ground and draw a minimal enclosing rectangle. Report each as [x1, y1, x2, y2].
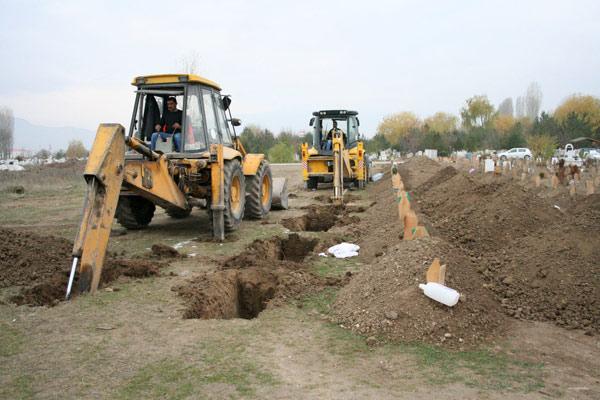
[67, 124, 126, 298]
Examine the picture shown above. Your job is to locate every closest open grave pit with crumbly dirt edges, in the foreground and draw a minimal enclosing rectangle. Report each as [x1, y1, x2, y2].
[172, 266, 341, 319]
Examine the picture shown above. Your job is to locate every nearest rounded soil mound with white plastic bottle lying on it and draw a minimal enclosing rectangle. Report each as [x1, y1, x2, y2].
[334, 238, 506, 348]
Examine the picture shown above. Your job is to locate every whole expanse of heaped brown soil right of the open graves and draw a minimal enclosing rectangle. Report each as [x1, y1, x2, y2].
[335, 158, 600, 347]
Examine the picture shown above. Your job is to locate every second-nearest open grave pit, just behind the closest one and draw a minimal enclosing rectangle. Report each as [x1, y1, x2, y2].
[222, 233, 319, 269]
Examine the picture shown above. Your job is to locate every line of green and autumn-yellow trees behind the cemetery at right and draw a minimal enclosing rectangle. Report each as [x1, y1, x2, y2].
[366, 83, 600, 161]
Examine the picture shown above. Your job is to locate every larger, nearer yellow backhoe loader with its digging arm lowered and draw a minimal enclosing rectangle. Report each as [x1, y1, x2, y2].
[67, 74, 287, 298]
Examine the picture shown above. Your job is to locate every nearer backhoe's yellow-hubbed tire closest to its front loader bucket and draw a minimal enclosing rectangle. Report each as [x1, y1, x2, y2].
[245, 160, 273, 219]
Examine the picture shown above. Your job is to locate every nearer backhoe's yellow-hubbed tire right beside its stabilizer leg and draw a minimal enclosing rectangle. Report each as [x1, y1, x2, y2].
[223, 159, 246, 232]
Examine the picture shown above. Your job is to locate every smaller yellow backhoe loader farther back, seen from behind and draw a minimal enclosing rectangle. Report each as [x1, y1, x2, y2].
[302, 110, 369, 203]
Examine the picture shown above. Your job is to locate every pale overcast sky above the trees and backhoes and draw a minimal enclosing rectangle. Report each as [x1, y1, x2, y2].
[0, 0, 600, 136]
